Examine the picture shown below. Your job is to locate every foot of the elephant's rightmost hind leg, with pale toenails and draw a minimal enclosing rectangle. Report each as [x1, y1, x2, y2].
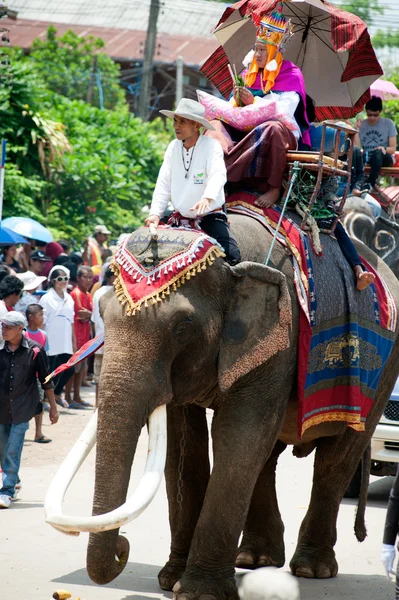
[290, 546, 338, 579]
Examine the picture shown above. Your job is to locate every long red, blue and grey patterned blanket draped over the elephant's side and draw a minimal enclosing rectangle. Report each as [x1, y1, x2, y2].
[227, 192, 397, 437]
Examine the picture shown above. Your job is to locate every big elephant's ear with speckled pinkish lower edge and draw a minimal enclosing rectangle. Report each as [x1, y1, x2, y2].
[219, 262, 292, 391]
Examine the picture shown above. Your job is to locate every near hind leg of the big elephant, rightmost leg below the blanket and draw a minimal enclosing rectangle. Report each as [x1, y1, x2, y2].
[290, 427, 371, 579]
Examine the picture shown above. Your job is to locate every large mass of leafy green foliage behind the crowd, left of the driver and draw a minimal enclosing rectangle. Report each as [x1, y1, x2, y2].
[0, 28, 171, 240]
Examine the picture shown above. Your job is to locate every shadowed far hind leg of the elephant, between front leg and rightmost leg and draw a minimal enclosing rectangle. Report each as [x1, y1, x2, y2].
[236, 441, 287, 569]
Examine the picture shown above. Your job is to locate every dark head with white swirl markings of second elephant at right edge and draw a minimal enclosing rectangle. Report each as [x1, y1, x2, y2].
[343, 197, 399, 278]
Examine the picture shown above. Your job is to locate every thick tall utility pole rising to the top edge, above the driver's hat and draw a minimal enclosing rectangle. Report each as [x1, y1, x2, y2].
[137, 0, 161, 121]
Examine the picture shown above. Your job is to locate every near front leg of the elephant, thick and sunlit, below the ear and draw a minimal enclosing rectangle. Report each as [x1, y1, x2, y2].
[173, 392, 288, 600]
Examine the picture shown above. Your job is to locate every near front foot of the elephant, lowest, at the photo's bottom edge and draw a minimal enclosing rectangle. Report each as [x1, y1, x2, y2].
[173, 572, 239, 600]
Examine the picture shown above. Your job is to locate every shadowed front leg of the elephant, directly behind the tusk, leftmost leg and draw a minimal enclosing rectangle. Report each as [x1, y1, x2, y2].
[158, 405, 210, 590]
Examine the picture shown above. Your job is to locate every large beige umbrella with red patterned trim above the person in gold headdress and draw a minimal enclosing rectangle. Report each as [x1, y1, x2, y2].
[201, 0, 383, 120]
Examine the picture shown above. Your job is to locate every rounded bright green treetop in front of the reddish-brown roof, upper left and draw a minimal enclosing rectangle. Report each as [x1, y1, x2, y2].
[30, 25, 125, 108]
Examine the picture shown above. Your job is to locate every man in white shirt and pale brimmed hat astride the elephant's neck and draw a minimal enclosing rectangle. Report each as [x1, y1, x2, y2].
[145, 98, 241, 265]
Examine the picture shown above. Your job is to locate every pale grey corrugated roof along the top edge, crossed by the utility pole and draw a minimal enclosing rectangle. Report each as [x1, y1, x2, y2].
[6, 0, 226, 37]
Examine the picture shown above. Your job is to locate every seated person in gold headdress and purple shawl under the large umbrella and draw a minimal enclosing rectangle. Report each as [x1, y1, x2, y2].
[206, 4, 310, 207]
